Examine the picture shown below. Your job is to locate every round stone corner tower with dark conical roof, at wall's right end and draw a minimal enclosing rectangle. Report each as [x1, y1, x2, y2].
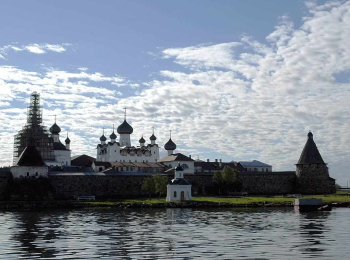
[296, 132, 336, 194]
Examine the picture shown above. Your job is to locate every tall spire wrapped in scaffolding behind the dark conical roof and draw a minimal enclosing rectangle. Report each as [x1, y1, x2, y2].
[13, 92, 55, 165]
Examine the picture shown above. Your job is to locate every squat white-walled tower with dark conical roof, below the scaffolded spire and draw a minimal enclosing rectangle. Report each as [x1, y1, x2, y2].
[11, 145, 49, 178]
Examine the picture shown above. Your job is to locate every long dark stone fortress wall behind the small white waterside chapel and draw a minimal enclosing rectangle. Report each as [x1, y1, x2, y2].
[0, 172, 326, 199]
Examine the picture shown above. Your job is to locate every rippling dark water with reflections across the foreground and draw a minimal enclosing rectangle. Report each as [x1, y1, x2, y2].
[0, 208, 350, 259]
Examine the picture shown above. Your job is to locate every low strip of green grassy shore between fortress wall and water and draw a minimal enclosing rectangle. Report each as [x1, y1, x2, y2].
[0, 194, 350, 210]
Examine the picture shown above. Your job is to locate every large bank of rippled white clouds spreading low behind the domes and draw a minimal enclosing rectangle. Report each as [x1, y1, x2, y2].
[0, 2, 350, 187]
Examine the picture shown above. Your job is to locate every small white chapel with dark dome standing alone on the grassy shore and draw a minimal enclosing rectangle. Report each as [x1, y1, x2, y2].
[166, 163, 192, 201]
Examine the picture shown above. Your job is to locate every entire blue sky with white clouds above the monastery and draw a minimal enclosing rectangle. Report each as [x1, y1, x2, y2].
[0, 0, 350, 185]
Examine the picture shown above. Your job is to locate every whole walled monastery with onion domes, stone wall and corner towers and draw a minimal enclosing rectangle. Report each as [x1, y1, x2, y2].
[0, 92, 335, 201]
